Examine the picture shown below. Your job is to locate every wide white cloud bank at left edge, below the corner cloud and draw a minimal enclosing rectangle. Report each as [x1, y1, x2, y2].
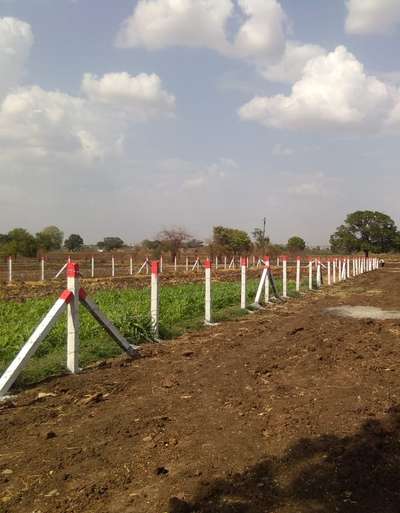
[0, 73, 175, 159]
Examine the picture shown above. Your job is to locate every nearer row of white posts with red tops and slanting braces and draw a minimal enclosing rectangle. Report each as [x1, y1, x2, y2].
[0, 256, 379, 398]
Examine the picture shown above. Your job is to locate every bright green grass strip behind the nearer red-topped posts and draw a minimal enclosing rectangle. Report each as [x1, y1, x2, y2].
[0, 279, 296, 385]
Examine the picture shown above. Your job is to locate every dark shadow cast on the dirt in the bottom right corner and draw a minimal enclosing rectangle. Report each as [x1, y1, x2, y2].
[168, 407, 400, 513]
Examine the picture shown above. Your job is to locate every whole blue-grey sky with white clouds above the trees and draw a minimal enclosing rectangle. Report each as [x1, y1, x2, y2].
[0, 0, 400, 245]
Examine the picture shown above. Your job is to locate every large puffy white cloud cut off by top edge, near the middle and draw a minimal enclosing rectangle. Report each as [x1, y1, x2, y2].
[116, 0, 312, 82]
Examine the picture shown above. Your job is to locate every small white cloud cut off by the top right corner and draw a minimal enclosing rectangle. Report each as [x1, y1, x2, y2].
[346, 0, 400, 34]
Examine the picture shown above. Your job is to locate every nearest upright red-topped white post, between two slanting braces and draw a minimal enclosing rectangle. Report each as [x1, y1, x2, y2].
[67, 262, 80, 374]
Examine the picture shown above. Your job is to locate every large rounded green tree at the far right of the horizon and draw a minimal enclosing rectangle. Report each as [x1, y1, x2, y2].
[330, 210, 399, 253]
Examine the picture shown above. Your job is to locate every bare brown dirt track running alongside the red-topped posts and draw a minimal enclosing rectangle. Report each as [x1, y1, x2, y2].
[0, 264, 400, 513]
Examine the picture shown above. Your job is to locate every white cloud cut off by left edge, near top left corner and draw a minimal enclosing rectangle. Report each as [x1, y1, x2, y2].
[0, 18, 33, 98]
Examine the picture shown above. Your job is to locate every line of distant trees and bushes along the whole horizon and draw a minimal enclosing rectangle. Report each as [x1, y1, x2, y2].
[0, 210, 400, 259]
